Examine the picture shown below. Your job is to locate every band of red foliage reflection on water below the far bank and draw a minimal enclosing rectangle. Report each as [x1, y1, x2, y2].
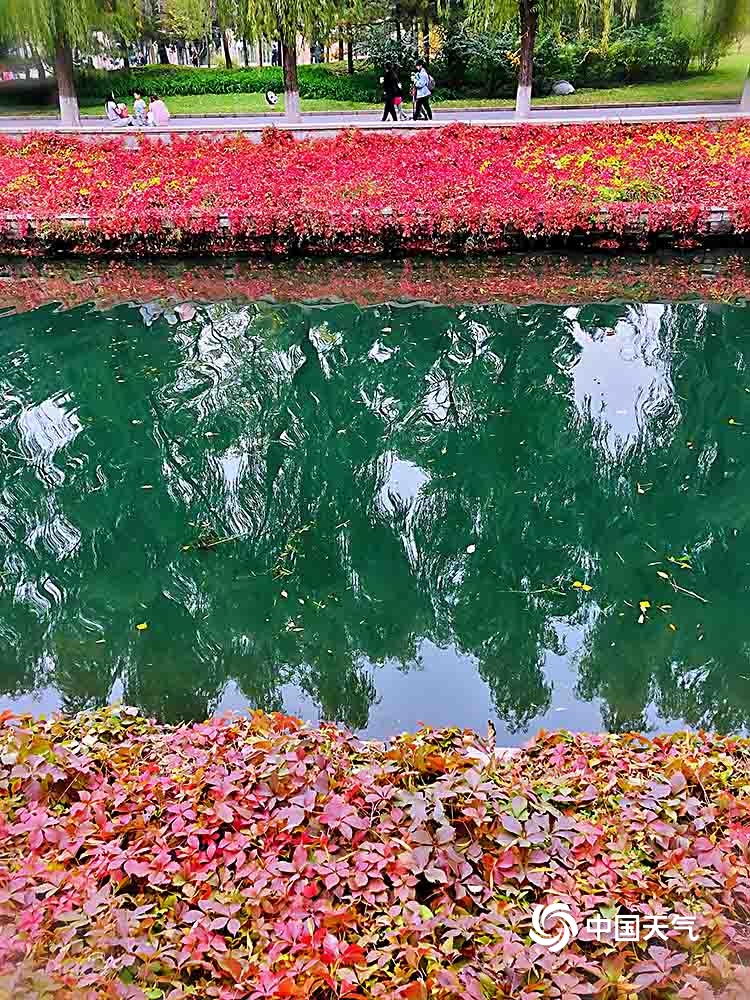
[0, 253, 750, 312]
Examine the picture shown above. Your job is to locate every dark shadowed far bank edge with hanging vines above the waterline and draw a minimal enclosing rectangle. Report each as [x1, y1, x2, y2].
[0, 203, 750, 259]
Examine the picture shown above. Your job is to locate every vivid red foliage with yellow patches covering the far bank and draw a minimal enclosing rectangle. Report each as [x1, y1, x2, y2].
[0, 120, 750, 253]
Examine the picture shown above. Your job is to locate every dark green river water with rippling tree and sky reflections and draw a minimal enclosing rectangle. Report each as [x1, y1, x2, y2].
[0, 266, 750, 744]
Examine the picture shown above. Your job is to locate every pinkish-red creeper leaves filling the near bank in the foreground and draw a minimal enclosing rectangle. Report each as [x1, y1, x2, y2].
[0, 707, 750, 1000]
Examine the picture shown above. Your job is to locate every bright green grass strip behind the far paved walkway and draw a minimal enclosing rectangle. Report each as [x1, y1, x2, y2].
[0, 45, 750, 118]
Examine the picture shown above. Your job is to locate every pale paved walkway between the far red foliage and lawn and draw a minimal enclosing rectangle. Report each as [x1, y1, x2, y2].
[0, 102, 742, 133]
